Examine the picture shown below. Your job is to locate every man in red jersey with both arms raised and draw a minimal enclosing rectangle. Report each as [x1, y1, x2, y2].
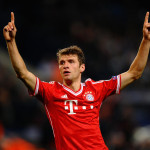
[3, 12, 150, 150]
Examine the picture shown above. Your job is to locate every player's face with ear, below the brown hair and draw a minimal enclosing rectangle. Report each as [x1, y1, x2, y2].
[59, 55, 85, 81]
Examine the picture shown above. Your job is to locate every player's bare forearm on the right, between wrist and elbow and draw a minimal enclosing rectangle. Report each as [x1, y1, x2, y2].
[129, 38, 150, 78]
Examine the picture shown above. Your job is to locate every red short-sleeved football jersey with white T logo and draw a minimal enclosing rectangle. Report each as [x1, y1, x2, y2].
[29, 75, 121, 150]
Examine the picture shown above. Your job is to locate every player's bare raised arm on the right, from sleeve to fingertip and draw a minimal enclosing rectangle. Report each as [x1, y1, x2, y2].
[121, 12, 150, 89]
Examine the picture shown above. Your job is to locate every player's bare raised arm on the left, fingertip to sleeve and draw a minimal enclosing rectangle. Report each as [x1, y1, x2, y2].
[3, 12, 36, 91]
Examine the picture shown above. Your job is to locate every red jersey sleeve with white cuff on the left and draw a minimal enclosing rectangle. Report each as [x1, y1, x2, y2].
[29, 77, 54, 103]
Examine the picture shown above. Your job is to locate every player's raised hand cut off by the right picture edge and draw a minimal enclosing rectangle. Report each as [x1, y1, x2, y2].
[143, 12, 150, 40]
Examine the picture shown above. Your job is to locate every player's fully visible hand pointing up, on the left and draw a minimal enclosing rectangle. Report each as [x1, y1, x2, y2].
[3, 12, 17, 41]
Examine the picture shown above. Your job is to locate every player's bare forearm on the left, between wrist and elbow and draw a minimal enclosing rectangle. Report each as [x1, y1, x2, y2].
[6, 39, 27, 78]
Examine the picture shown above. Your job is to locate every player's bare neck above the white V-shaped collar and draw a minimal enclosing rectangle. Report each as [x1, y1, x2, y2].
[63, 80, 81, 92]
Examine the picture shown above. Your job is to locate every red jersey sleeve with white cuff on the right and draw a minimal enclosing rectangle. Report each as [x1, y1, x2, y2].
[103, 75, 121, 97]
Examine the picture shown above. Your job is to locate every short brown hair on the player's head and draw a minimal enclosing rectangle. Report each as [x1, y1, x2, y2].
[57, 45, 85, 65]
